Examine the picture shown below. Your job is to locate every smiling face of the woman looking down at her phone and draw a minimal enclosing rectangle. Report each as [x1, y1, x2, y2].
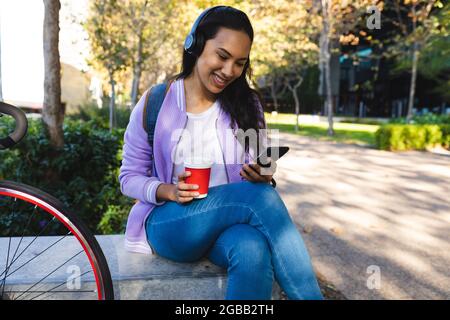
[195, 27, 252, 94]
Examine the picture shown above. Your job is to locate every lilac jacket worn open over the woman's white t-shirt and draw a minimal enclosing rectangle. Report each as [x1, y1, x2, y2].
[119, 79, 262, 254]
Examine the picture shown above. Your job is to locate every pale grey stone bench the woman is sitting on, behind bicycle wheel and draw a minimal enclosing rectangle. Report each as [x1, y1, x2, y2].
[0, 235, 281, 300]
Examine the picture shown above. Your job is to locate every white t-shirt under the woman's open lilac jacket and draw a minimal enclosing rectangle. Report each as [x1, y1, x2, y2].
[172, 100, 228, 187]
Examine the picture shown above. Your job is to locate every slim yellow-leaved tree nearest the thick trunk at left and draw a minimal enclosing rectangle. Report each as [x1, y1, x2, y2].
[84, 0, 130, 131]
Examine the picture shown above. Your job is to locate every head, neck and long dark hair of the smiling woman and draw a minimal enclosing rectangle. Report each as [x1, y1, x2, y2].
[174, 7, 265, 131]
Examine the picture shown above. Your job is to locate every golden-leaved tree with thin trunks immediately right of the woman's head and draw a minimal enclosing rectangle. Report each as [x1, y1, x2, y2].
[250, 0, 319, 127]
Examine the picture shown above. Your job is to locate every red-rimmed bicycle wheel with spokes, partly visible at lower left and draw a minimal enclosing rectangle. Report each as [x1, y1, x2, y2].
[0, 180, 114, 300]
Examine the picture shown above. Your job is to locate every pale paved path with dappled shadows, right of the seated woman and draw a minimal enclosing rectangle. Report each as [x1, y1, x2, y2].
[275, 134, 450, 299]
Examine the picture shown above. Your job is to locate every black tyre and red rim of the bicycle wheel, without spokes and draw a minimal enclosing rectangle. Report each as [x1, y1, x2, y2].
[0, 180, 114, 300]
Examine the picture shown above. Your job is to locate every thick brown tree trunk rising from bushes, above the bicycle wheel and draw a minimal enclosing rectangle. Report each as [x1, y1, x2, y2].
[42, 0, 64, 148]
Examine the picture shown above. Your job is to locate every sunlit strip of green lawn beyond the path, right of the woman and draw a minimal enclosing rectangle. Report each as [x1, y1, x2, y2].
[265, 114, 379, 146]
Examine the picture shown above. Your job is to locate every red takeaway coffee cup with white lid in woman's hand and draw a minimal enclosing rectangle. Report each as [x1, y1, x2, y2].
[184, 158, 212, 199]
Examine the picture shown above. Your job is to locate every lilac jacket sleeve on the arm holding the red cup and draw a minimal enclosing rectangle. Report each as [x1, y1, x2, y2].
[119, 92, 165, 205]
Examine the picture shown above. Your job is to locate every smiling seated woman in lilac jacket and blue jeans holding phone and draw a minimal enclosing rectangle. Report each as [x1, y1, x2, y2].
[119, 6, 322, 300]
